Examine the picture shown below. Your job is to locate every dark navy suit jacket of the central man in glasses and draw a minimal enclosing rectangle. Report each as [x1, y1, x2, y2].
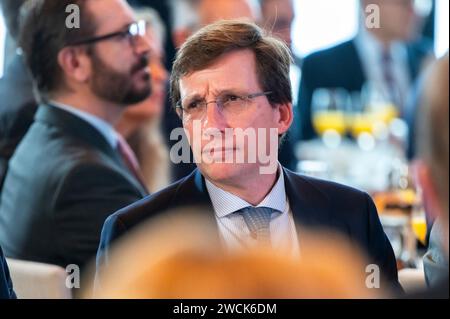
[97, 169, 397, 292]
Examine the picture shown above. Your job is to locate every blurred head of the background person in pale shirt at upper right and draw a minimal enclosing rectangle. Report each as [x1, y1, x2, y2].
[361, 0, 418, 46]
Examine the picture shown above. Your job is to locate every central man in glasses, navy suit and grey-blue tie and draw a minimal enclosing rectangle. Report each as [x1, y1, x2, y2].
[97, 21, 397, 285]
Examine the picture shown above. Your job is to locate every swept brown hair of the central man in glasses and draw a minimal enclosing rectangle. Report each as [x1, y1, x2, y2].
[170, 20, 292, 107]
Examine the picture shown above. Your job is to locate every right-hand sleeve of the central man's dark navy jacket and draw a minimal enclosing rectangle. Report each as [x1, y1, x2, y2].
[365, 194, 401, 291]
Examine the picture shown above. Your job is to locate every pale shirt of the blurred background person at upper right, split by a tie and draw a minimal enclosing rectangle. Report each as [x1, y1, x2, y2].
[355, 28, 411, 110]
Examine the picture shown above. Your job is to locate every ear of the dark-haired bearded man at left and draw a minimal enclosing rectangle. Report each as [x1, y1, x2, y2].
[58, 47, 91, 82]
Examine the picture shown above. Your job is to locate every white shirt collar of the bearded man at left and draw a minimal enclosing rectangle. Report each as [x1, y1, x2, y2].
[49, 101, 118, 149]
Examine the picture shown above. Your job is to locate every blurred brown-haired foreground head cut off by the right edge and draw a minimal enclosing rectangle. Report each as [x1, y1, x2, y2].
[417, 54, 449, 214]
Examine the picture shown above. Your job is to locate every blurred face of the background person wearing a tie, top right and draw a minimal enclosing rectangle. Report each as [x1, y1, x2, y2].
[368, 0, 418, 41]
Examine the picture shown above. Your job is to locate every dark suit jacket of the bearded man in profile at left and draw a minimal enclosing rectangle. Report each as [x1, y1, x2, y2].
[0, 105, 146, 267]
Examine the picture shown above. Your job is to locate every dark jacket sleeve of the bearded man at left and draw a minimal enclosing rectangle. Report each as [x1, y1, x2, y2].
[54, 163, 142, 267]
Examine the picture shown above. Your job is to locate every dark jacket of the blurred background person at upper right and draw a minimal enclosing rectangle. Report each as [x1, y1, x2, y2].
[297, 40, 430, 140]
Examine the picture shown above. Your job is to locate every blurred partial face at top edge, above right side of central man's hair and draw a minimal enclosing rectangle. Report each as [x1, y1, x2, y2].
[259, 0, 295, 48]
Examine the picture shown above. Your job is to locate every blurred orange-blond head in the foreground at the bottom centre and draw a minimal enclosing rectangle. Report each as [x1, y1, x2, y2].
[84, 208, 381, 299]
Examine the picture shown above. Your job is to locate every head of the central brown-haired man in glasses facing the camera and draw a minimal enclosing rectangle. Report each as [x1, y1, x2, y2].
[171, 20, 293, 204]
